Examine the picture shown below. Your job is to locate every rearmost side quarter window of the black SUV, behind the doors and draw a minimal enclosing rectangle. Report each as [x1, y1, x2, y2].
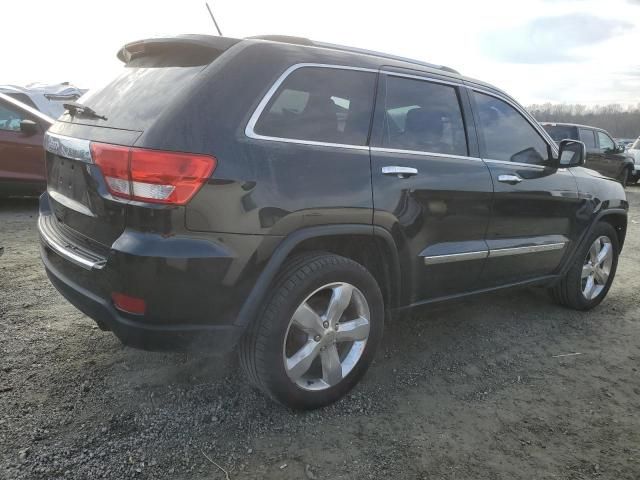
[254, 67, 376, 145]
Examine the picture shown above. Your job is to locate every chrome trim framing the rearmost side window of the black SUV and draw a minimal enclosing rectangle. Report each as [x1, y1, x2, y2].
[244, 63, 378, 150]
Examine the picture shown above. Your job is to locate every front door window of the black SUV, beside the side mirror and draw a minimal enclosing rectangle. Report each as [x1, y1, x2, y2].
[473, 92, 549, 165]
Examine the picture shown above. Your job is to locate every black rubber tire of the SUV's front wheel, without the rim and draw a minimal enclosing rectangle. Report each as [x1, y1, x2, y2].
[550, 222, 620, 310]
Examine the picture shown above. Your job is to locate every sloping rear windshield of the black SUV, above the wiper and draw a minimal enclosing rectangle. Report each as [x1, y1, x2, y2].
[62, 54, 212, 131]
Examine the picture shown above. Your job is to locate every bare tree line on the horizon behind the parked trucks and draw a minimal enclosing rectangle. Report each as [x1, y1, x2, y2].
[528, 103, 640, 138]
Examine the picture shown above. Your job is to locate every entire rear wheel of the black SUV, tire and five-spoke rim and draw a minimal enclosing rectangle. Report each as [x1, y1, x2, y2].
[239, 252, 384, 410]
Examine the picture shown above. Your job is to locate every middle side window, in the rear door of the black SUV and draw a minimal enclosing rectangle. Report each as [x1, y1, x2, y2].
[382, 75, 468, 155]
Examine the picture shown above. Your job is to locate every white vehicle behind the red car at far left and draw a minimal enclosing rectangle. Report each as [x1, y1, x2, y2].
[0, 82, 86, 119]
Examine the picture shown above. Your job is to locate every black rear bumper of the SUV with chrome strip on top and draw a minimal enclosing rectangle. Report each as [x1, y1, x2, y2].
[38, 193, 263, 353]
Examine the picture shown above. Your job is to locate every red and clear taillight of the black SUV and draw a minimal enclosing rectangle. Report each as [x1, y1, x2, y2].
[91, 142, 216, 205]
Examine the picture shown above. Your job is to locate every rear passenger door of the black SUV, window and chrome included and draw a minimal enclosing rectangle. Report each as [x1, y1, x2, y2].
[371, 69, 493, 303]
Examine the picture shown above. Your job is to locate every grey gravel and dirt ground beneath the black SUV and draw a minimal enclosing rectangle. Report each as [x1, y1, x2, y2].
[0, 187, 640, 480]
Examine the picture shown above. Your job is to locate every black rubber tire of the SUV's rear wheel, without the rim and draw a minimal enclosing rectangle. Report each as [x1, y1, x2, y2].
[239, 252, 384, 410]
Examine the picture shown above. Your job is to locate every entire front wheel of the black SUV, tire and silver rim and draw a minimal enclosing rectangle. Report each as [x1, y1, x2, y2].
[551, 222, 619, 310]
